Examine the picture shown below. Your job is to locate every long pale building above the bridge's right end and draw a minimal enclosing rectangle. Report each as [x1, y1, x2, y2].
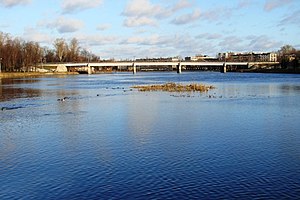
[218, 52, 277, 62]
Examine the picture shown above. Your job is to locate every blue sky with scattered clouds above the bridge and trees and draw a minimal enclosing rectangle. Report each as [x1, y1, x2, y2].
[0, 0, 300, 59]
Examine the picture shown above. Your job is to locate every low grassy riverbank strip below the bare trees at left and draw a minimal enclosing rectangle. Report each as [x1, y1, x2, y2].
[0, 72, 79, 78]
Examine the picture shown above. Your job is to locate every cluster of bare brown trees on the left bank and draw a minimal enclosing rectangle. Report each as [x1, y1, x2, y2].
[0, 32, 100, 72]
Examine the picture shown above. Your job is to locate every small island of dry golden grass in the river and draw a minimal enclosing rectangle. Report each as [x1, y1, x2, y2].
[132, 83, 215, 92]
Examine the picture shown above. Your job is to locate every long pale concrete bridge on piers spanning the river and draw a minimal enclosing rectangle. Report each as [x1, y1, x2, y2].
[43, 61, 279, 74]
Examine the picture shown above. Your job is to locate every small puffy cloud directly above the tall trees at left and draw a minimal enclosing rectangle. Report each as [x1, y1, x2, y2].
[46, 16, 84, 33]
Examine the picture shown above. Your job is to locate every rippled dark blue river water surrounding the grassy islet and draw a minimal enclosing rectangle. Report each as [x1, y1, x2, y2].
[0, 72, 300, 199]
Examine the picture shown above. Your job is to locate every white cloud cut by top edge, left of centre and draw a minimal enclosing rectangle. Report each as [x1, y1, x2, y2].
[61, 0, 103, 13]
